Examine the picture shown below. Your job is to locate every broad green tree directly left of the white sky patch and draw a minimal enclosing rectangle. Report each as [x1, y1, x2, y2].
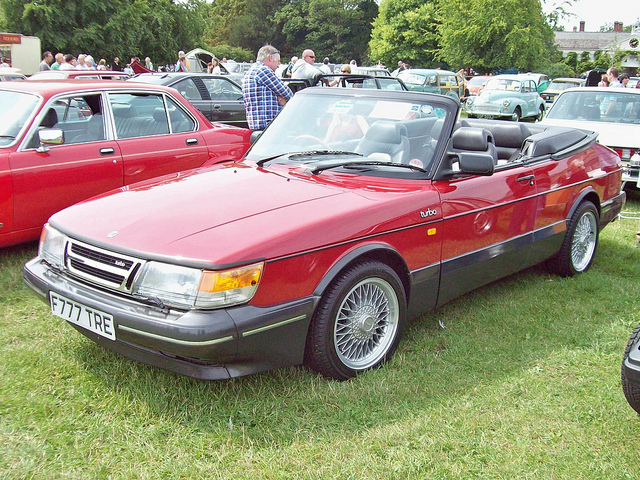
[439, 0, 555, 72]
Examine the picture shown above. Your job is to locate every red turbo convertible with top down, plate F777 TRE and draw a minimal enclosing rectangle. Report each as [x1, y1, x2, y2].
[23, 87, 625, 379]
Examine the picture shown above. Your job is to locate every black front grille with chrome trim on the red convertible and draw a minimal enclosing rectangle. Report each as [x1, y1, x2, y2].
[65, 240, 144, 293]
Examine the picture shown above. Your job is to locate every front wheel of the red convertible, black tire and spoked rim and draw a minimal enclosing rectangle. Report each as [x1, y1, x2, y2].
[305, 260, 407, 380]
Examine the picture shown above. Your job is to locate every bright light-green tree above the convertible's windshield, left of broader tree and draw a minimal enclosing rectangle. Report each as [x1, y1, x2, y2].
[369, 0, 444, 67]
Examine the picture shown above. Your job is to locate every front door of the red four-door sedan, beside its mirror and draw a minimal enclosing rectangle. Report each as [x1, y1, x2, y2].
[9, 93, 123, 230]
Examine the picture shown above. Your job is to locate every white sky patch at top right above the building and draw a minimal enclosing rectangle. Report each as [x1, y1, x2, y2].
[543, 0, 640, 32]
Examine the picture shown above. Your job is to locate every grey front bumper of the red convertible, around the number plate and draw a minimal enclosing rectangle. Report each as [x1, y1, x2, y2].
[23, 258, 319, 380]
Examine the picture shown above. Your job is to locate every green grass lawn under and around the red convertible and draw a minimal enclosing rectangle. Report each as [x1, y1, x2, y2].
[0, 197, 640, 480]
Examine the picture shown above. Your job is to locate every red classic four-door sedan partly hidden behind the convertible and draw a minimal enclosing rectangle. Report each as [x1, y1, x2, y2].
[0, 81, 250, 247]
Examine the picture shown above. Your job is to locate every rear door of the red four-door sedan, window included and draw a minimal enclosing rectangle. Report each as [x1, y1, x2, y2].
[108, 92, 209, 185]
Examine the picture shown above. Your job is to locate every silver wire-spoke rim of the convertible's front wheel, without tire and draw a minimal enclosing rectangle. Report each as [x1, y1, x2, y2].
[334, 278, 398, 370]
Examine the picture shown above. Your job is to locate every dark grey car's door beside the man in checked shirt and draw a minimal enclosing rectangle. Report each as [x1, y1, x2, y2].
[198, 77, 247, 127]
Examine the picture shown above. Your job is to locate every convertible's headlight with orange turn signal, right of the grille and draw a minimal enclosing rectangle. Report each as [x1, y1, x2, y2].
[132, 262, 263, 308]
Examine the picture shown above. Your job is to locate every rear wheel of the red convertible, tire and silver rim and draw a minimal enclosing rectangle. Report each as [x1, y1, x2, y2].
[549, 201, 599, 277]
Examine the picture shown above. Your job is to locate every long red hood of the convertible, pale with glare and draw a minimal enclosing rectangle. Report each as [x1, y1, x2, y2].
[50, 162, 426, 266]
